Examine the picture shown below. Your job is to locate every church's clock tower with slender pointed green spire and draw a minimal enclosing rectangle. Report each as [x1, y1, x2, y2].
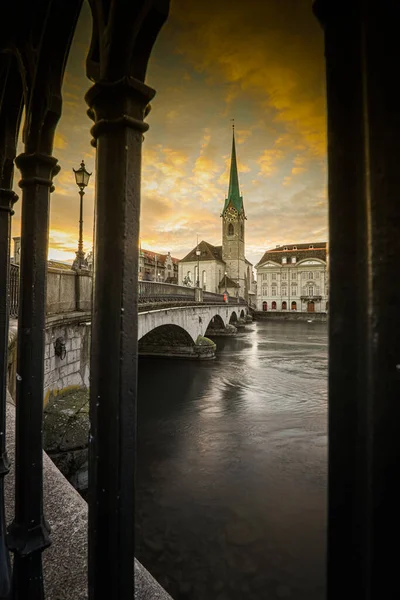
[221, 125, 248, 297]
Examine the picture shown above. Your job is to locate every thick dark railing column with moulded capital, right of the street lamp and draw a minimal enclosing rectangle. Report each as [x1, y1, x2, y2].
[86, 77, 155, 600]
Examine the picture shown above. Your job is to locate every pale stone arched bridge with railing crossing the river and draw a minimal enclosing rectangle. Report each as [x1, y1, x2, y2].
[8, 265, 248, 404]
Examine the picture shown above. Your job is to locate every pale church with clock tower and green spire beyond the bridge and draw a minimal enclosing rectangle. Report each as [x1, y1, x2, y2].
[178, 129, 253, 300]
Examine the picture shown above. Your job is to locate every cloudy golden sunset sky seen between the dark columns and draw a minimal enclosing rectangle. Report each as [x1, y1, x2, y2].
[13, 0, 328, 263]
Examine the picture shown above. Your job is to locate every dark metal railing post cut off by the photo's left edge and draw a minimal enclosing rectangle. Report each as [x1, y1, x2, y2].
[0, 188, 18, 599]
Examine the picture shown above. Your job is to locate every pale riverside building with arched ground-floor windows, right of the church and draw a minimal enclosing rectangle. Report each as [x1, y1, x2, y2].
[255, 242, 329, 312]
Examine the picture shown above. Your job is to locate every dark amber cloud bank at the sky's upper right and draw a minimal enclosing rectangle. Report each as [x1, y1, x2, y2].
[171, 0, 326, 156]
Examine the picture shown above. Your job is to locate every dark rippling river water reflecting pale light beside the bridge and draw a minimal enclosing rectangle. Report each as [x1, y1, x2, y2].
[136, 321, 328, 600]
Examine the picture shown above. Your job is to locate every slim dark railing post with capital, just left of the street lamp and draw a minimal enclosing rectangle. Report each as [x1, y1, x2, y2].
[8, 154, 58, 600]
